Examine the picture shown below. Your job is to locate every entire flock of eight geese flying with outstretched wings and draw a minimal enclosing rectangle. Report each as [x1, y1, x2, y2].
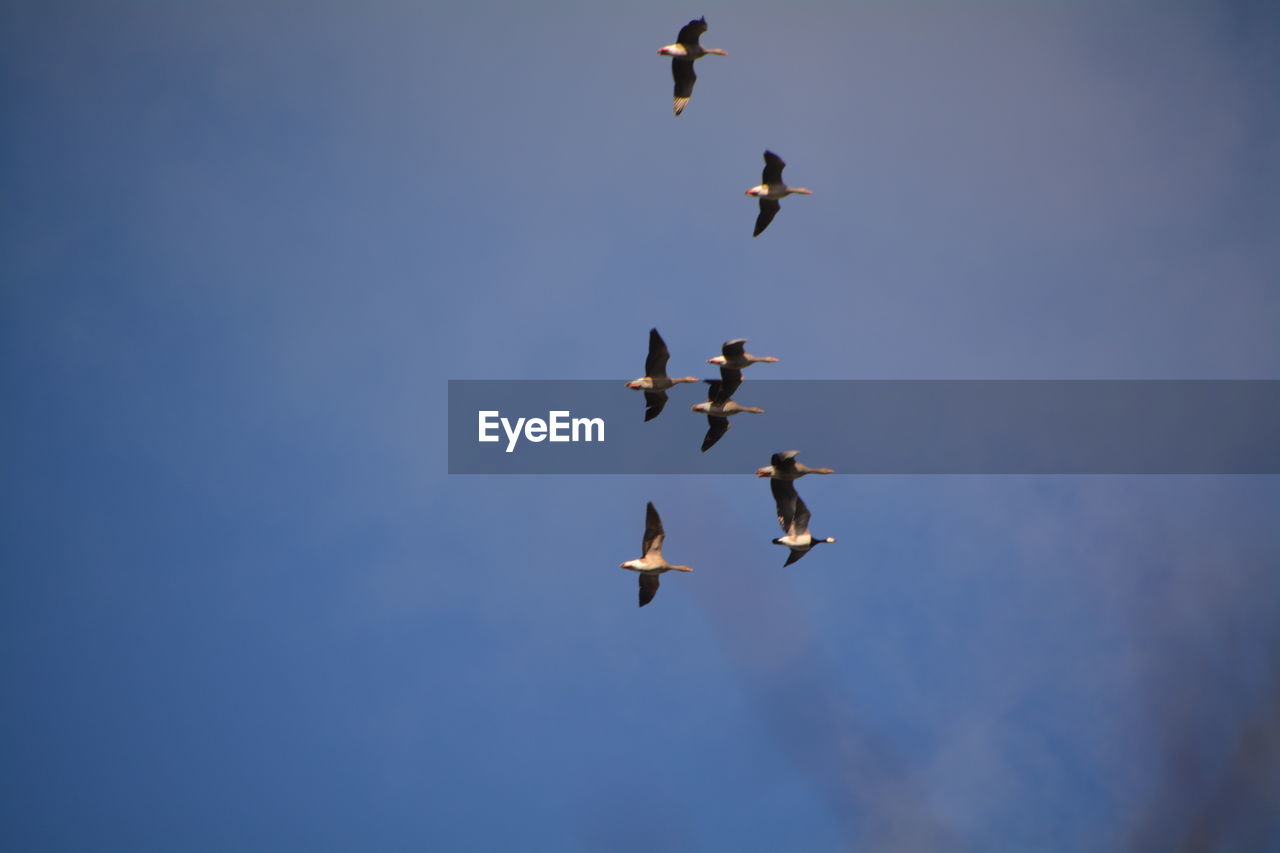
[621, 18, 836, 607]
